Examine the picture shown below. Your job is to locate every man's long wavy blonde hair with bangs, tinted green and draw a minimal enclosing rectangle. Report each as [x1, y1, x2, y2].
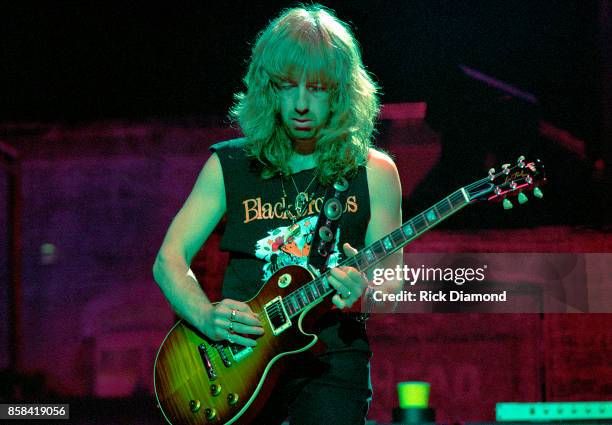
[230, 5, 380, 184]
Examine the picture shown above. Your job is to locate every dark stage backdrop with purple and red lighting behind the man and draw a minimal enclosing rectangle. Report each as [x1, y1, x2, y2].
[0, 0, 612, 423]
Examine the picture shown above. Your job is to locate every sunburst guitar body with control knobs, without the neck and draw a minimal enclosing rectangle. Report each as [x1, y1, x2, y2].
[154, 266, 317, 425]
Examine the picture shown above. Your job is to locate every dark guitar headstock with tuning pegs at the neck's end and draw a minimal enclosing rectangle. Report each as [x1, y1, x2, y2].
[464, 156, 546, 209]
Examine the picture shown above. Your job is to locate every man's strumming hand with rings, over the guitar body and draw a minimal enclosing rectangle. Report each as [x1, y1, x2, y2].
[198, 298, 264, 347]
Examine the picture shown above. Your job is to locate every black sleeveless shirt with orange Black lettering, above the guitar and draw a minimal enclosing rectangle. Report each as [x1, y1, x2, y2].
[211, 138, 370, 301]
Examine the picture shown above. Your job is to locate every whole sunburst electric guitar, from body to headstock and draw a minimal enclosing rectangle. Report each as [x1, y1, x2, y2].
[154, 157, 545, 425]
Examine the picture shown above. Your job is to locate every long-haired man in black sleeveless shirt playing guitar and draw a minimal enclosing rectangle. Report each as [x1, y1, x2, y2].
[154, 5, 402, 425]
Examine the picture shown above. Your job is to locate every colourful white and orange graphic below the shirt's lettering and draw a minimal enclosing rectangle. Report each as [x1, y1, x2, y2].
[255, 216, 340, 282]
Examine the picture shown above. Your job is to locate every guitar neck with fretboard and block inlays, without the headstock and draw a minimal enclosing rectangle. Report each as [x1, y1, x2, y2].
[283, 188, 471, 317]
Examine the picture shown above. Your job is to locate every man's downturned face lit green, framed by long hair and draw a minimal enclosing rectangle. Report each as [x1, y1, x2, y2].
[277, 75, 330, 147]
